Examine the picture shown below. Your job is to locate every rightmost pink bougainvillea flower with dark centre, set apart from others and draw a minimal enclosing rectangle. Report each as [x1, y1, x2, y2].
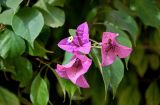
[101, 32, 132, 66]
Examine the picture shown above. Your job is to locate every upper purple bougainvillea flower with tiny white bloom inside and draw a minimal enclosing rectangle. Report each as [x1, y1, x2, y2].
[58, 22, 91, 54]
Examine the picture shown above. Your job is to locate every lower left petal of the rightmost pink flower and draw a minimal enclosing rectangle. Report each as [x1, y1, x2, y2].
[101, 45, 116, 67]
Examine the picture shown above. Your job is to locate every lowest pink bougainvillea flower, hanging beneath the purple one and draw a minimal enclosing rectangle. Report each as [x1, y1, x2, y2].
[56, 54, 92, 88]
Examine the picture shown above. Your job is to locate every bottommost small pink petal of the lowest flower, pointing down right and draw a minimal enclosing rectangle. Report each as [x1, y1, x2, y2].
[76, 76, 89, 88]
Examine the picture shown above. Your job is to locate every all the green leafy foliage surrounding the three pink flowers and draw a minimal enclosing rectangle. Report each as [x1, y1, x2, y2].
[0, 0, 160, 105]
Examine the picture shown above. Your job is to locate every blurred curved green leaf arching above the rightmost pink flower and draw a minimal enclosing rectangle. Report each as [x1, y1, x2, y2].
[106, 10, 138, 44]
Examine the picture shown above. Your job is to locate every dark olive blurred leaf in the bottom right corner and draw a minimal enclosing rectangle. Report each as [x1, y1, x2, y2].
[145, 81, 160, 105]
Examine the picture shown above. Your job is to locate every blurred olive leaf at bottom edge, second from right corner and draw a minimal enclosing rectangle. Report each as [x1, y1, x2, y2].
[118, 86, 141, 105]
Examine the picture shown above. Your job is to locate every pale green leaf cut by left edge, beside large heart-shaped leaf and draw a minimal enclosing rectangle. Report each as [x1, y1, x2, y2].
[0, 9, 14, 25]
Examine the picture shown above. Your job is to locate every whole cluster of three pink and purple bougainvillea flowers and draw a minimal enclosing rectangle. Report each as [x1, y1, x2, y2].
[56, 22, 132, 88]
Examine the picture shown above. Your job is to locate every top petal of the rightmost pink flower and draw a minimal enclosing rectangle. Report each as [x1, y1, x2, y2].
[102, 32, 118, 43]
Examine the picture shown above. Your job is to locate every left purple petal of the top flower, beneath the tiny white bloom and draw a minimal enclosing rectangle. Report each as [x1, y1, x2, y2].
[58, 38, 76, 52]
